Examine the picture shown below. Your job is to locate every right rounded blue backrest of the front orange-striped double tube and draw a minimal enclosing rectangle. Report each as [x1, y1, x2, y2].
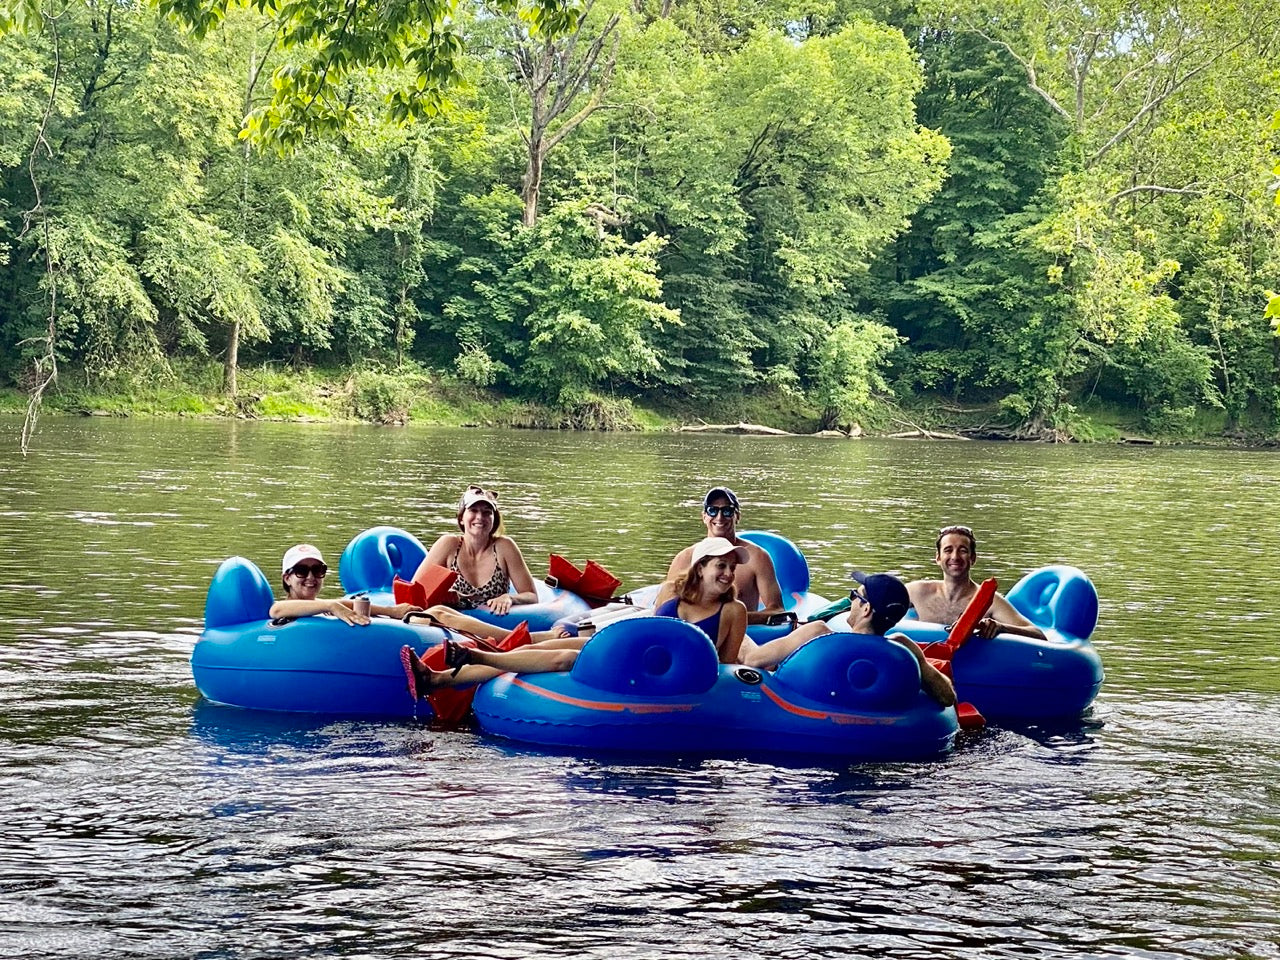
[773, 634, 920, 713]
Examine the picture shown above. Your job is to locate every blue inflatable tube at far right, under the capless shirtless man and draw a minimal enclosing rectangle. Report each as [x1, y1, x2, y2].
[880, 566, 1105, 723]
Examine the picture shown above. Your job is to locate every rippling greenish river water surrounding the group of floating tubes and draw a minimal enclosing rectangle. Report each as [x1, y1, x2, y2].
[0, 419, 1280, 959]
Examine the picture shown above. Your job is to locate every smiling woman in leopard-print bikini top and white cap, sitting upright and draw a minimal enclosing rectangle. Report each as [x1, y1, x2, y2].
[422, 484, 538, 613]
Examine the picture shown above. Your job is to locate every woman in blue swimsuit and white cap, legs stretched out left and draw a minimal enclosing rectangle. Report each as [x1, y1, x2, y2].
[401, 536, 746, 696]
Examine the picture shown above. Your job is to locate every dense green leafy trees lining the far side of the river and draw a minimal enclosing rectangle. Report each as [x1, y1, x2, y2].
[0, 0, 1280, 434]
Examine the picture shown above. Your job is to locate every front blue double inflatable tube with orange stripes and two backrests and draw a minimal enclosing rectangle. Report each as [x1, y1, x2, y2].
[472, 617, 957, 762]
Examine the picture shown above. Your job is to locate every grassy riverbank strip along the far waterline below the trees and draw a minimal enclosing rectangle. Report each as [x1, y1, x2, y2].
[0, 362, 1275, 443]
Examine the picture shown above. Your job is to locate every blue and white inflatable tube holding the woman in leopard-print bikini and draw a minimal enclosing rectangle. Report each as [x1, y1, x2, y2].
[338, 526, 591, 630]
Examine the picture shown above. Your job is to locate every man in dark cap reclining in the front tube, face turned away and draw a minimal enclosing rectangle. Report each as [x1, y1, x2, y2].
[739, 573, 956, 707]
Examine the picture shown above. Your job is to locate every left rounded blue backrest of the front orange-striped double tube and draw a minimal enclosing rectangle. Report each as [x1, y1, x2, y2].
[570, 617, 719, 696]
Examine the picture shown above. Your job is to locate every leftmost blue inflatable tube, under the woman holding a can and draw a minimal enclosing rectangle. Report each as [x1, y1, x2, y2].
[191, 557, 444, 717]
